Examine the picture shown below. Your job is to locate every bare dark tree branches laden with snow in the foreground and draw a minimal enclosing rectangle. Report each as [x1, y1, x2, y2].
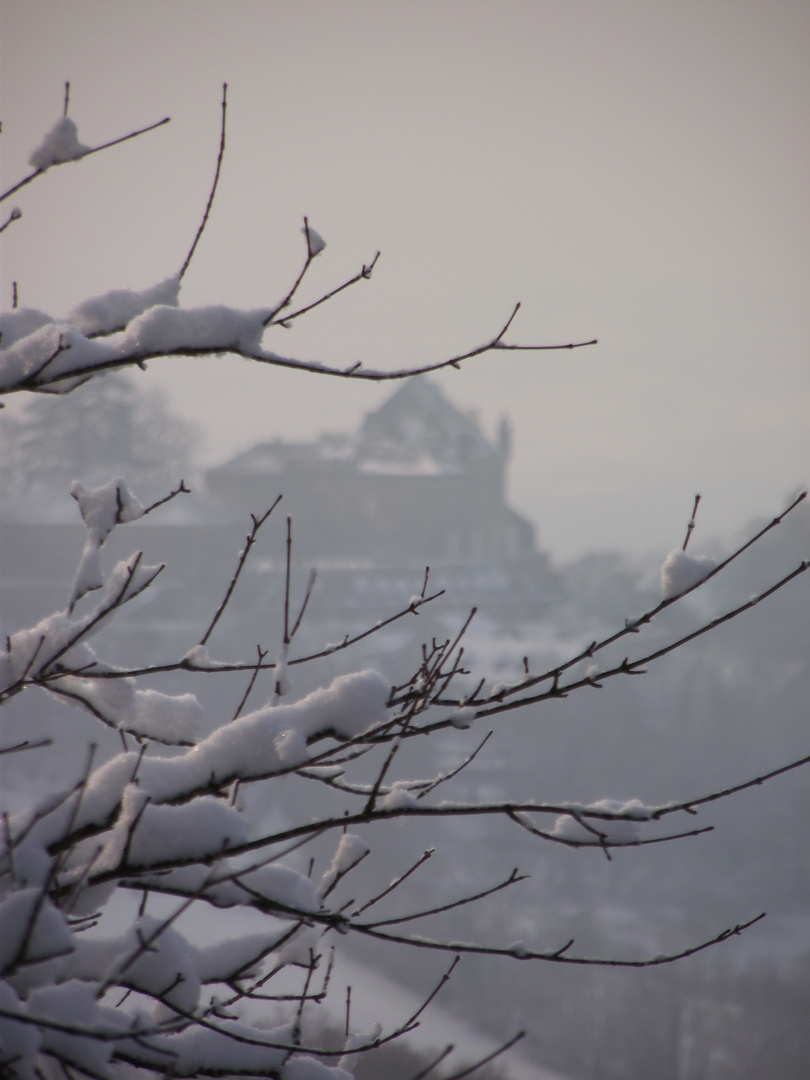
[0, 88, 810, 1080]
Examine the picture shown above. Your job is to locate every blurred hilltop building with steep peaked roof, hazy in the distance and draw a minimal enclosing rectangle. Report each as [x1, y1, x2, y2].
[206, 377, 538, 568]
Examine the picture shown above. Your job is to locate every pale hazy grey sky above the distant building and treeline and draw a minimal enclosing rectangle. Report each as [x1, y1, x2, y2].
[0, 0, 810, 559]
